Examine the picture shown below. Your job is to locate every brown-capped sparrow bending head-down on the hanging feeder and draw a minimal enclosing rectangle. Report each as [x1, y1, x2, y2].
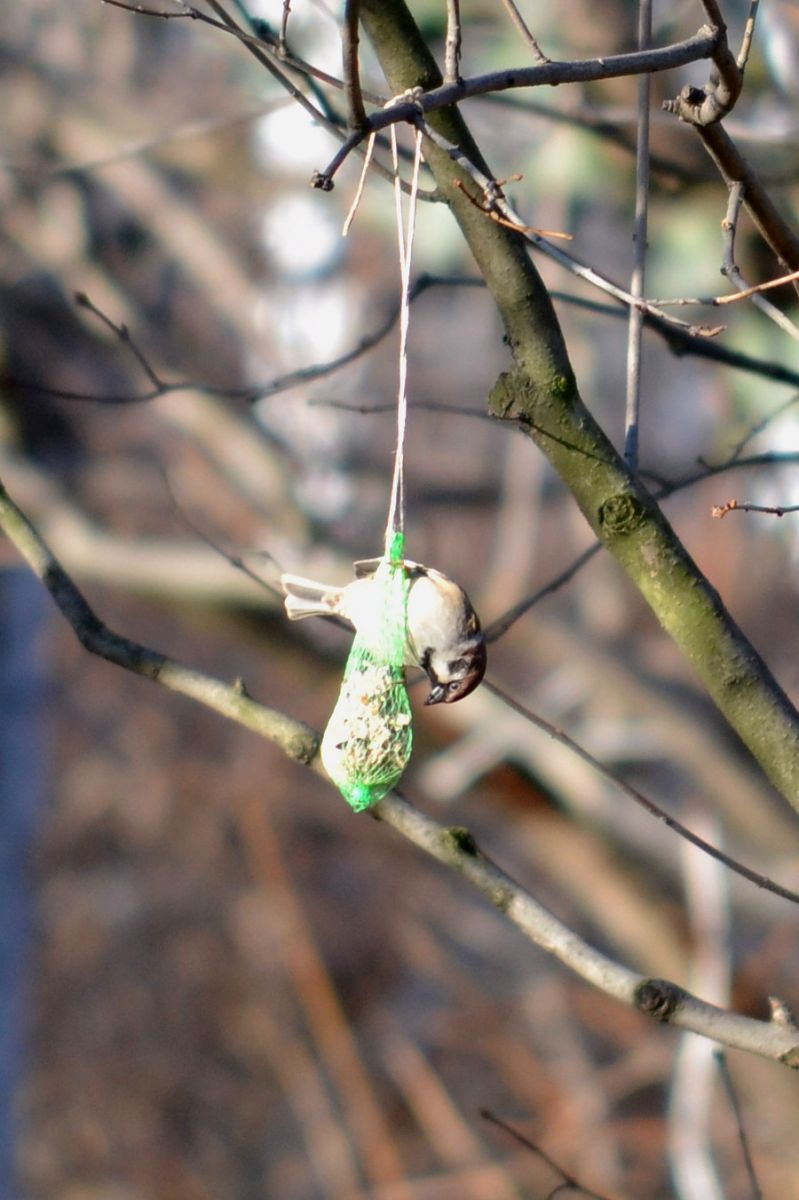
[281, 558, 486, 704]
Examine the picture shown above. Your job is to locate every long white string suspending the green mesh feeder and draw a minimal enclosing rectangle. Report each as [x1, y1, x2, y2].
[385, 125, 421, 557]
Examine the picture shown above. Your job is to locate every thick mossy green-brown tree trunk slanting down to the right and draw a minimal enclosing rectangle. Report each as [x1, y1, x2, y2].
[361, 0, 799, 811]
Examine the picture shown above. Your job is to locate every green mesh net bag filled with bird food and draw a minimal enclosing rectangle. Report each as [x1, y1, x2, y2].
[322, 533, 413, 812]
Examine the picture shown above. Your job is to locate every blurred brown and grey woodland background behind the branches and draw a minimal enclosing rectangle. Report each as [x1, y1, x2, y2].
[0, 0, 799, 1200]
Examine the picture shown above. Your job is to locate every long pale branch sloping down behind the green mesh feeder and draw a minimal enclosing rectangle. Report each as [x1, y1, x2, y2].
[0, 470, 799, 1068]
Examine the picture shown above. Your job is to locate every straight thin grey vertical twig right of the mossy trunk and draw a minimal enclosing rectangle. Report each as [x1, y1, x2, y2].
[624, 0, 651, 472]
